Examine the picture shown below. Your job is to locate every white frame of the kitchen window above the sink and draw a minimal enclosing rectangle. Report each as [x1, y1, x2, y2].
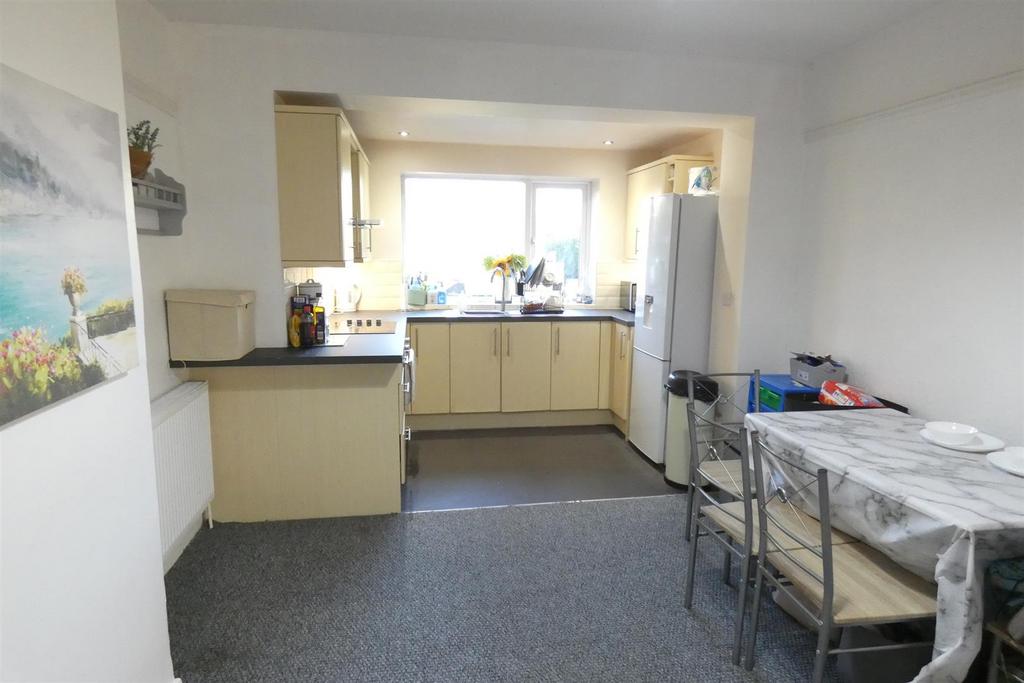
[401, 172, 596, 295]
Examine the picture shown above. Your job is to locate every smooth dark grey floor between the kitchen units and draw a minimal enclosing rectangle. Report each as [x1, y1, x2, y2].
[402, 427, 677, 510]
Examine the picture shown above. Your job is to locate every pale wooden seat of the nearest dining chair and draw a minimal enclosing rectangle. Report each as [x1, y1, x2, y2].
[767, 543, 937, 626]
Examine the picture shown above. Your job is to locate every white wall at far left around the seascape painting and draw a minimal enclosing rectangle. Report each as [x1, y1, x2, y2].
[0, 2, 172, 683]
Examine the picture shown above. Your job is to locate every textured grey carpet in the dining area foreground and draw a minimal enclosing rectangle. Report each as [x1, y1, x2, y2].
[167, 496, 839, 683]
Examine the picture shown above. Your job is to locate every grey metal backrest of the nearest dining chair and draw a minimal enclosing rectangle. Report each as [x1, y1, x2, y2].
[749, 431, 834, 622]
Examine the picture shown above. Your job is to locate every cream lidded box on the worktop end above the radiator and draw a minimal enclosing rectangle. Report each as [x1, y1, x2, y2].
[164, 290, 256, 360]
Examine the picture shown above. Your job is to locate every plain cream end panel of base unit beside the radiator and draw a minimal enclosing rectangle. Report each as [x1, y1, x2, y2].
[188, 364, 402, 522]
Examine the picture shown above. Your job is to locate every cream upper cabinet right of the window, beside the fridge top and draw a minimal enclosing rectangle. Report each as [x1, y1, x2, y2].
[623, 155, 715, 260]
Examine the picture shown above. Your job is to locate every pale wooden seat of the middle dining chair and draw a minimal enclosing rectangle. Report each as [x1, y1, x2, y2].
[702, 501, 857, 554]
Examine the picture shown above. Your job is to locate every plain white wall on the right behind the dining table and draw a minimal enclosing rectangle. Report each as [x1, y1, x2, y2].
[799, 3, 1024, 443]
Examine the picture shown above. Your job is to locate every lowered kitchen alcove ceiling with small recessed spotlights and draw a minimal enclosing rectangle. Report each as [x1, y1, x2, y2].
[341, 96, 726, 151]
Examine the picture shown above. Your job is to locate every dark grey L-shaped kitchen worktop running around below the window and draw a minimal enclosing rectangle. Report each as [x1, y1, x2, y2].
[170, 308, 633, 368]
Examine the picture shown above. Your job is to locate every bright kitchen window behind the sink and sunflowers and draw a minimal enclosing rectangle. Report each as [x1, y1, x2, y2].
[402, 174, 592, 302]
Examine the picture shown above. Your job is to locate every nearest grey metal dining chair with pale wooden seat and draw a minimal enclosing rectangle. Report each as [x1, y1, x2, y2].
[746, 431, 936, 683]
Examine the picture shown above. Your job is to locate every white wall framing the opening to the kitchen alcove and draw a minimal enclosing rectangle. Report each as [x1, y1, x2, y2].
[136, 18, 803, 378]
